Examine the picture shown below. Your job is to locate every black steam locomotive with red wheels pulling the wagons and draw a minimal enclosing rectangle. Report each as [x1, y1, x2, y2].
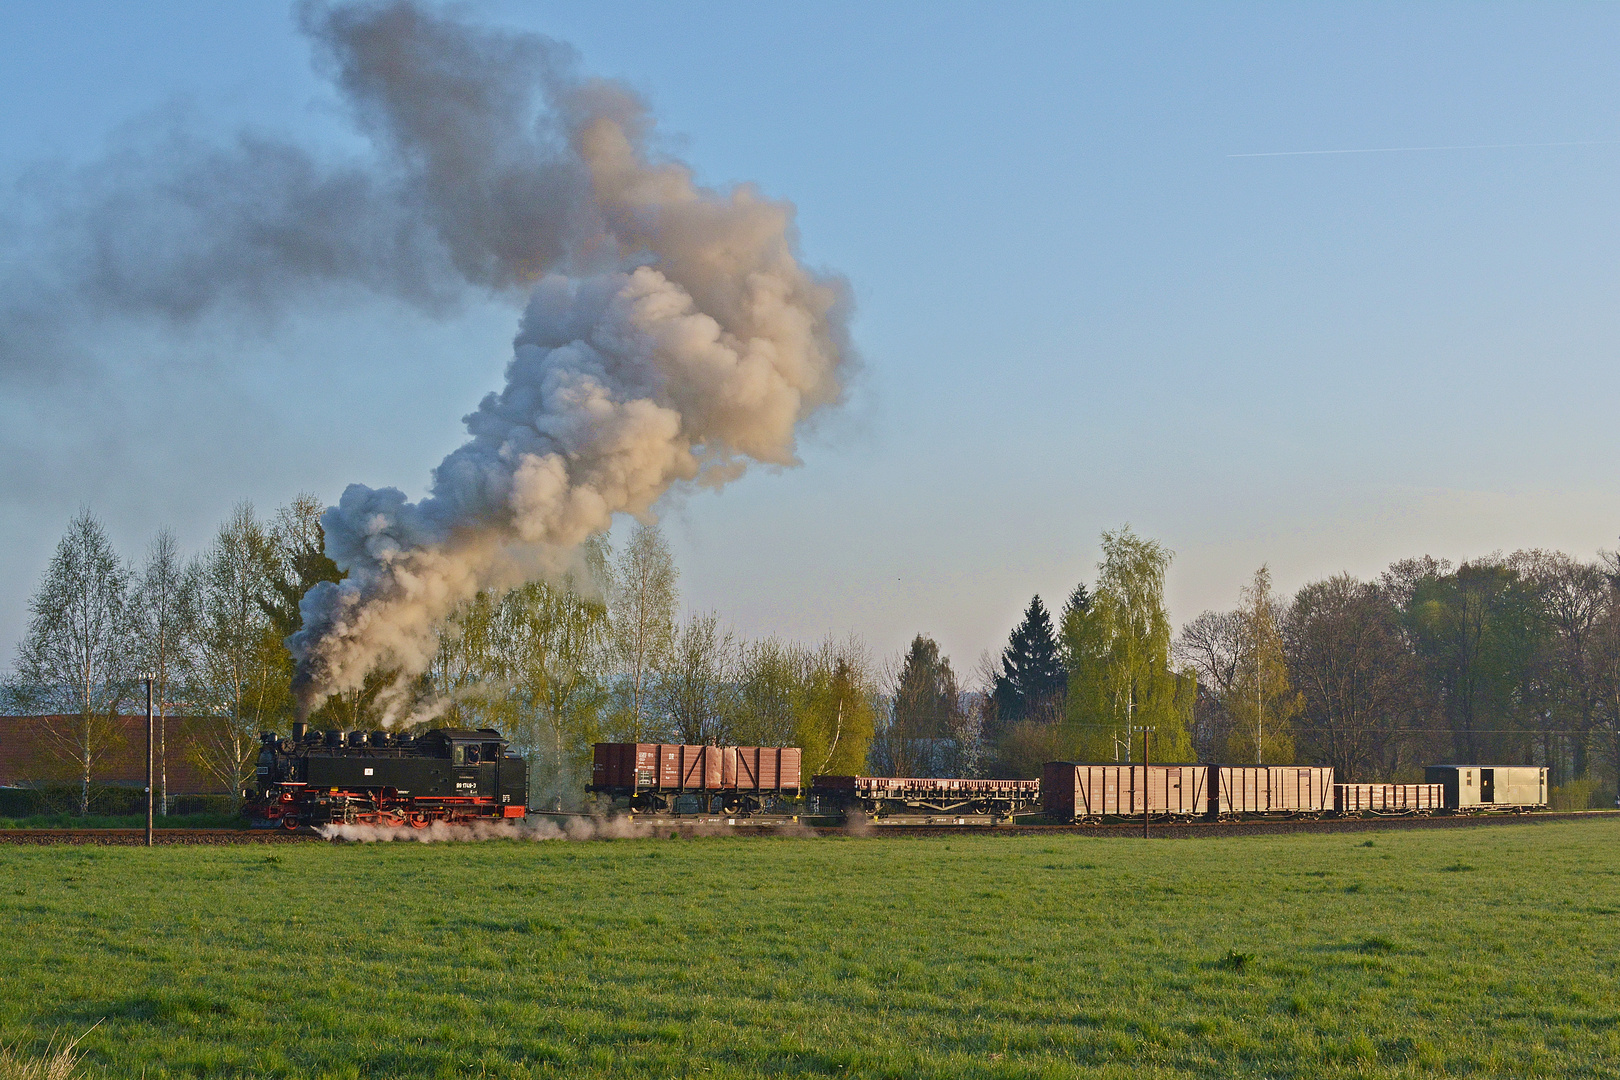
[246, 724, 528, 831]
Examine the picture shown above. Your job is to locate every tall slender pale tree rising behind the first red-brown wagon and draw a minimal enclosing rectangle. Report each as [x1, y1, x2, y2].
[611, 521, 679, 742]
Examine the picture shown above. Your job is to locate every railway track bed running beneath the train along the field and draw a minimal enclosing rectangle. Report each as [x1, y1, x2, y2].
[0, 810, 1620, 847]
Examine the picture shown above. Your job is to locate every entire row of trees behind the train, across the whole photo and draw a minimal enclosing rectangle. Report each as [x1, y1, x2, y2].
[5, 508, 1620, 801]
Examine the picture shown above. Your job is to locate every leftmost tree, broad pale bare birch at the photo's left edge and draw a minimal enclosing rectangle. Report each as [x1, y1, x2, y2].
[6, 508, 138, 813]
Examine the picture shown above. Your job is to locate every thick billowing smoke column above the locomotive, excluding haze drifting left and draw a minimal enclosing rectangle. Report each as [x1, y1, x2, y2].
[288, 2, 851, 708]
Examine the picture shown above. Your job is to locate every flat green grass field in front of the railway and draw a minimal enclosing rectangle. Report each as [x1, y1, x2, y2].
[0, 821, 1620, 1080]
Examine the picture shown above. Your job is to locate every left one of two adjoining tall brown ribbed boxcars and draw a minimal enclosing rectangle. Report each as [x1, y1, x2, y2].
[1040, 761, 1210, 821]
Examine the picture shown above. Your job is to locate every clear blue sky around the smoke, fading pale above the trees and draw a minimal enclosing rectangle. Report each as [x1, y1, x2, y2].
[0, 0, 1620, 670]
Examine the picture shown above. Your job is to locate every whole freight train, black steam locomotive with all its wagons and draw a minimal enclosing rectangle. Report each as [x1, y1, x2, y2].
[245, 724, 1547, 829]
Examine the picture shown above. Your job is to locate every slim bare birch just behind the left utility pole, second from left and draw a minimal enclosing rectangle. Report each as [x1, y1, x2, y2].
[133, 529, 196, 816]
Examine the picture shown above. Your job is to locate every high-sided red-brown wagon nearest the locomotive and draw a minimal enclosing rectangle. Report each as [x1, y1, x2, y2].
[586, 743, 800, 816]
